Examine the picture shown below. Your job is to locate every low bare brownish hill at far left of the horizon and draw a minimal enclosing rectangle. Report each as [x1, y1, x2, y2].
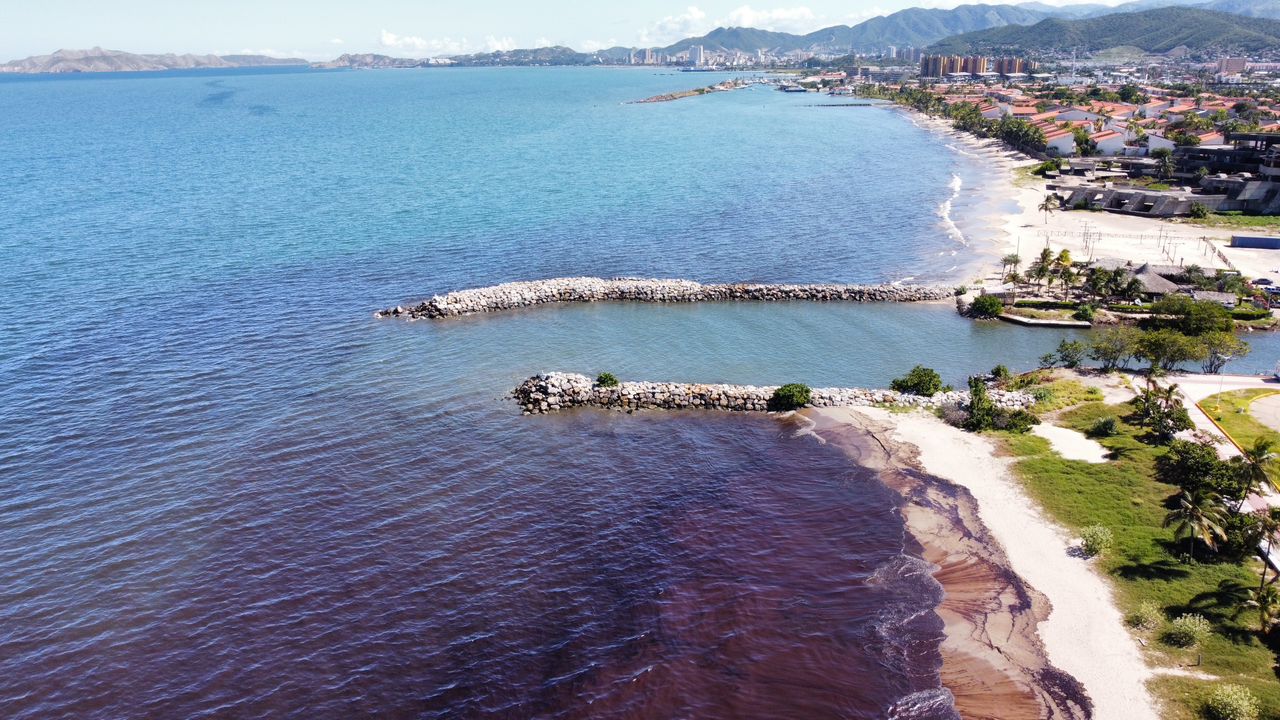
[0, 47, 307, 73]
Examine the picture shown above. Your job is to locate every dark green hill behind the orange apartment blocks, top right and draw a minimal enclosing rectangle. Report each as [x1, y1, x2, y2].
[929, 8, 1280, 54]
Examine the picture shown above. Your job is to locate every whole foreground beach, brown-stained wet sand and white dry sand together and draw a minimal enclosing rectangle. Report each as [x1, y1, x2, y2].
[803, 407, 1158, 720]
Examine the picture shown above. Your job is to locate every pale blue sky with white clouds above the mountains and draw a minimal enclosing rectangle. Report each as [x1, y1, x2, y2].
[0, 0, 1119, 61]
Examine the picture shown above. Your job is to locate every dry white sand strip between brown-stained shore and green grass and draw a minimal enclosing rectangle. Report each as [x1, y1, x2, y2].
[839, 409, 1160, 720]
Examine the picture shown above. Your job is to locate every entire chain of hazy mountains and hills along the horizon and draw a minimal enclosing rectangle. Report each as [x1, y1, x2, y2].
[0, 0, 1280, 73]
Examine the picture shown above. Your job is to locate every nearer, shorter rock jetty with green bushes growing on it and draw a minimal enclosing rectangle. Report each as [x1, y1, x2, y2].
[512, 373, 1036, 414]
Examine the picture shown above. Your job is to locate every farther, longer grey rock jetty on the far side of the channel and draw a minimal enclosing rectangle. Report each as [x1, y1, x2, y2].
[376, 278, 955, 320]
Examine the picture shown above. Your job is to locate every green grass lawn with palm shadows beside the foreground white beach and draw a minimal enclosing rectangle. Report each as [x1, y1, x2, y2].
[1005, 394, 1280, 720]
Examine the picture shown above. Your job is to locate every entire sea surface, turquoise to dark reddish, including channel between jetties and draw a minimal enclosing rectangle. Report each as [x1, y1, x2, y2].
[0, 64, 1280, 719]
